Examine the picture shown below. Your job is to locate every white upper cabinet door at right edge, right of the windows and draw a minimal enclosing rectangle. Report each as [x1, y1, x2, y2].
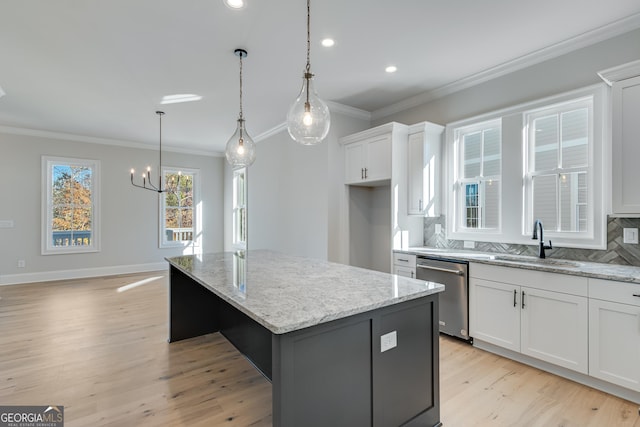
[612, 76, 640, 214]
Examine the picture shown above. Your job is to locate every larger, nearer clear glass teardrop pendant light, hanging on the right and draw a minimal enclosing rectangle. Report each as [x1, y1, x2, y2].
[287, 0, 331, 145]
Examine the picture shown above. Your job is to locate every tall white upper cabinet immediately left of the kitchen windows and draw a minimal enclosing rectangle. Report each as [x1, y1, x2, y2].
[407, 122, 444, 217]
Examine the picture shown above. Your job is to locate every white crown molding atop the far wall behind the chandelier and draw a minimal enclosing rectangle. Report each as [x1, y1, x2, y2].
[0, 125, 224, 157]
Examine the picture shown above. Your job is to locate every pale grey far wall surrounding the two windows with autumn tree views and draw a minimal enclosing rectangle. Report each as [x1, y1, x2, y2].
[0, 133, 223, 284]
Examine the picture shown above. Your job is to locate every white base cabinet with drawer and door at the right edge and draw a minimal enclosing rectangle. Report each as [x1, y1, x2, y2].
[589, 279, 640, 392]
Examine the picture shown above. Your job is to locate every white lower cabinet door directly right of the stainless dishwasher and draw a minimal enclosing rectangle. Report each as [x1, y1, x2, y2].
[469, 278, 520, 351]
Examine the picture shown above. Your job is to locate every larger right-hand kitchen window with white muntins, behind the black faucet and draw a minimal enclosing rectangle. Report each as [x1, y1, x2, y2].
[525, 97, 593, 236]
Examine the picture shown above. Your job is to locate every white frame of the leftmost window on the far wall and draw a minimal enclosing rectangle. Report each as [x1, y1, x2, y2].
[41, 156, 101, 255]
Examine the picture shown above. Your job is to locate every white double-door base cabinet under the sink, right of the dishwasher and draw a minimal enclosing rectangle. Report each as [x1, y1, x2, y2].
[469, 263, 588, 374]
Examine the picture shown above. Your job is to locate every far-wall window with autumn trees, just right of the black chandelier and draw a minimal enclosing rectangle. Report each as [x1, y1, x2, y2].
[160, 168, 200, 248]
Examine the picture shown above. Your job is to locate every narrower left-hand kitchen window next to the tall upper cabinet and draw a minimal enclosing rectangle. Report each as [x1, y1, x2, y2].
[454, 120, 502, 232]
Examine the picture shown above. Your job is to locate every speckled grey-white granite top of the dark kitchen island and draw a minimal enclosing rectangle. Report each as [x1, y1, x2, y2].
[167, 250, 444, 334]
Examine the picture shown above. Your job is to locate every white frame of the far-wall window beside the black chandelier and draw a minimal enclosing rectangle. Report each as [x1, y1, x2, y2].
[158, 166, 202, 249]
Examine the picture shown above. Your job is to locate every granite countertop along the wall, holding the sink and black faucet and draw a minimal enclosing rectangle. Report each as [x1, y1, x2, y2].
[396, 247, 640, 284]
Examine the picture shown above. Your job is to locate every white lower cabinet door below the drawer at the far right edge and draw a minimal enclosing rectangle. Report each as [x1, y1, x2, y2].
[589, 299, 640, 391]
